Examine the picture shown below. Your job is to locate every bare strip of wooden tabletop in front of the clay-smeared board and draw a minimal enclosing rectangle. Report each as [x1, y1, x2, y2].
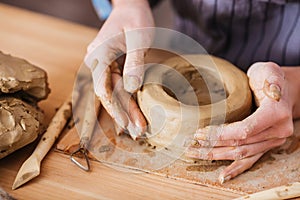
[0, 151, 237, 199]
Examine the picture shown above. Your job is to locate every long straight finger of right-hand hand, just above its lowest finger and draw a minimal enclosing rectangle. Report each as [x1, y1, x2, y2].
[186, 139, 286, 160]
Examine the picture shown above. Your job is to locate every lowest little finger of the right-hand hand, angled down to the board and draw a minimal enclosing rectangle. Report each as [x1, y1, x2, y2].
[219, 153, 264, 184]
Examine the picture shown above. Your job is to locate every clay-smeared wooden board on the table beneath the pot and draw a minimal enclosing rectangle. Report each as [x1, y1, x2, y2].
[57, 86, 300, 194]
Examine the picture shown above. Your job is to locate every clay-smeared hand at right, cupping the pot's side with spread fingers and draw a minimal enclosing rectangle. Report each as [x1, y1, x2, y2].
[187, 62, 300, 183]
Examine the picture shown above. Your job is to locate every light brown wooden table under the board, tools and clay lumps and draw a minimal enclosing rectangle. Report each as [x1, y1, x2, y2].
[0, 4, 239, 199]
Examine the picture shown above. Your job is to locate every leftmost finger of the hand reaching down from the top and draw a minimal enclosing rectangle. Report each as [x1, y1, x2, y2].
[92, 63, 128, 128]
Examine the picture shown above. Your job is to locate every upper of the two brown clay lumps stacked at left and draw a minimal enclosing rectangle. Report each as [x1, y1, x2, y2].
[0, 51, 49, 100]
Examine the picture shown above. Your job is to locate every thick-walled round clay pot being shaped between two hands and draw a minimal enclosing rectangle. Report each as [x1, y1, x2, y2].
[137, 55, 252, 150]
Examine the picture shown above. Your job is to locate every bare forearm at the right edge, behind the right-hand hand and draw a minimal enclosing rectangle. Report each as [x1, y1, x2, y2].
[282, 66, 300, 119]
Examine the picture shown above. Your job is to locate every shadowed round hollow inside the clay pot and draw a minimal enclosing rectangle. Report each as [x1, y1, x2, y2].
[162, 65, 227, 106]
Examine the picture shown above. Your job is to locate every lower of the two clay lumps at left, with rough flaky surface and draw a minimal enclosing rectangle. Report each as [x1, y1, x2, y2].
[0, 97, 43, 158]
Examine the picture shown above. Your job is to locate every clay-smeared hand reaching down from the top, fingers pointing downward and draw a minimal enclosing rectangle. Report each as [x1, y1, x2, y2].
[85, 0, 154, 139]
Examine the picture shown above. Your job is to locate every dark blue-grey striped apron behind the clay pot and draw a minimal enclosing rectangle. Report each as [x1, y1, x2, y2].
[151, 0, 300, 70]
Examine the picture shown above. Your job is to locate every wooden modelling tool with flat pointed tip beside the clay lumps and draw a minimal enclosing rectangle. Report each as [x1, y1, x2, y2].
[12, 95, 72, 190]
